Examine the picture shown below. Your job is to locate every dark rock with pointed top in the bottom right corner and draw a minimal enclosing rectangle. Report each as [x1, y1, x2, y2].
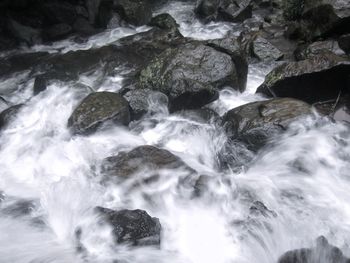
[278, 236, 350, 263]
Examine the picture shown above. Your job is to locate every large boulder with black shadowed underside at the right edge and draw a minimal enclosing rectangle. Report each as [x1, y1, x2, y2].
[257, 53, 350, 103]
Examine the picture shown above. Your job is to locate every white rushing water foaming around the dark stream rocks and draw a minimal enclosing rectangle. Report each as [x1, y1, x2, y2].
[0, 3, 350, 263]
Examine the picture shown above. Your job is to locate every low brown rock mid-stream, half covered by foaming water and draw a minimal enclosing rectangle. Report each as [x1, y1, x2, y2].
[102, 145, 191, 179]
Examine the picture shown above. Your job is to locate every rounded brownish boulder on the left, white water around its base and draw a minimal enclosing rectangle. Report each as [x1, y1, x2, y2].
[68, 91, 130, 134]
